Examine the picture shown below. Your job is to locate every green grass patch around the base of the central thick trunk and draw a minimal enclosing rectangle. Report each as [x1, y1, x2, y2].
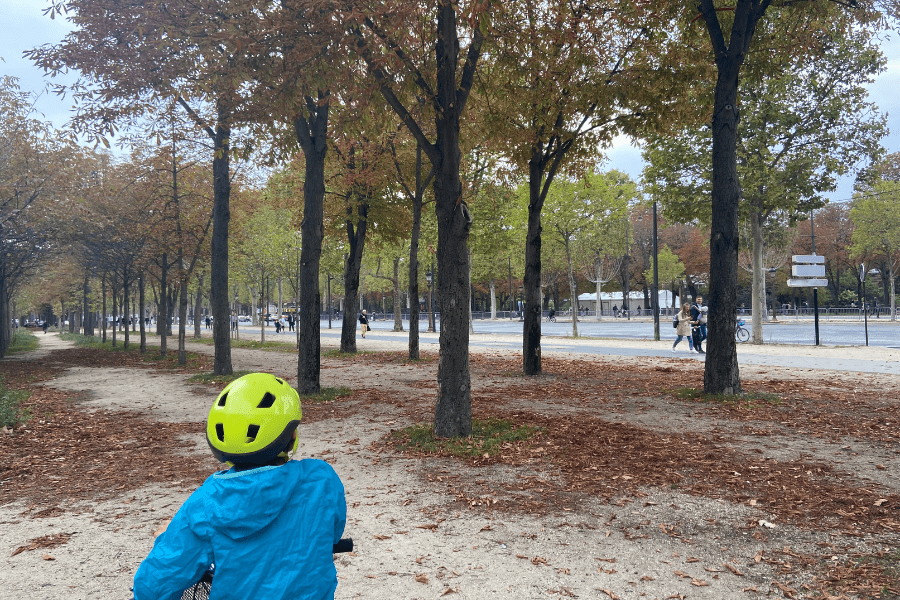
[391, 417, 539, 458]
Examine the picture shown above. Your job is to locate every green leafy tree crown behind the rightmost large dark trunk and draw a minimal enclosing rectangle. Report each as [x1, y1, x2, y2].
[644, 31, 885, 224]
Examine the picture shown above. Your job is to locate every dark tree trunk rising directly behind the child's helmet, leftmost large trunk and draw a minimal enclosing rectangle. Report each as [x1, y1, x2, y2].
[209, 100, 232, 375]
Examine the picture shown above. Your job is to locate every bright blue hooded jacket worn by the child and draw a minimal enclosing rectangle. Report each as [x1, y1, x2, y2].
[134, 459, 347, 600]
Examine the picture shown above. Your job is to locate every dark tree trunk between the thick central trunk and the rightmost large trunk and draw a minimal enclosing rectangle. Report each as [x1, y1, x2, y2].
[509, 152, 540, 375]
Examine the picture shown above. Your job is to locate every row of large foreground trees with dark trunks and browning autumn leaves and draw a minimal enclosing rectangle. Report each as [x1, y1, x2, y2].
[12, 0, 897, 435]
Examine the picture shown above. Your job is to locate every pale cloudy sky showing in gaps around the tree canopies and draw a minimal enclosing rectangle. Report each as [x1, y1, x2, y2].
[0, 0, 900, 201]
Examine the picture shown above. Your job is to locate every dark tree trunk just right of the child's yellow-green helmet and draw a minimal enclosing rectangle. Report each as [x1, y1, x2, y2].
[294, 99, 328, 394]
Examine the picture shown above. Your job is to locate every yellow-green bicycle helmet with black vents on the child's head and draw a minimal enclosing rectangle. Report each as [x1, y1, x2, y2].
[206, 373, 303, 465]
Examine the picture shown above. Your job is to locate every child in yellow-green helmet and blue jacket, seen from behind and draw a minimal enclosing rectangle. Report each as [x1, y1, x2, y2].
[134, 373, 347, 600]
